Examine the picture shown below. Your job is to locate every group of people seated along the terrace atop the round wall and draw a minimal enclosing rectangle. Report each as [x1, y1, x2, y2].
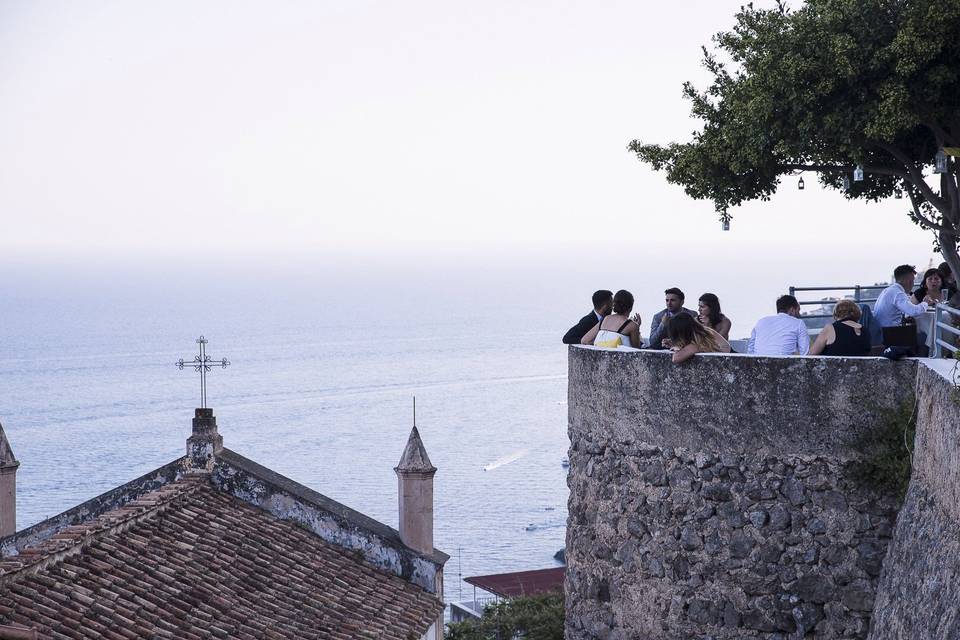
[563, 263, 957, 362]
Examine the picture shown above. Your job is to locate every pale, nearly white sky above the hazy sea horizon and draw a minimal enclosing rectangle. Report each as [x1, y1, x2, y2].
[0, 0, 930, 272]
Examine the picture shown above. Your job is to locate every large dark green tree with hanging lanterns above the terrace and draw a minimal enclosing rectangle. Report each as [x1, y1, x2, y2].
[630, 0, 960, 274]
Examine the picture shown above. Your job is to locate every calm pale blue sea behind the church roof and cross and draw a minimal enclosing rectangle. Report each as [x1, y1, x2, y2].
[0, 268, 572, 600]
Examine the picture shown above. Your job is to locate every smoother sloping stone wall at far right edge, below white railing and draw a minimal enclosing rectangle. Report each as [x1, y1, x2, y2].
[870, 362, 960, 640]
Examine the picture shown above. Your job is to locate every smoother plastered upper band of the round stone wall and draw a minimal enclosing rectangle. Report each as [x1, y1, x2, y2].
[568, 345, 919, 459]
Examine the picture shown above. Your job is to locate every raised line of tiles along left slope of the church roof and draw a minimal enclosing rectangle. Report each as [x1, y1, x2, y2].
[0, 474, 209, 585]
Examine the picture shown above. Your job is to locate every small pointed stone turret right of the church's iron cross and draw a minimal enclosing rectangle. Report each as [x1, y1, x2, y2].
[393, 427, 437, 554]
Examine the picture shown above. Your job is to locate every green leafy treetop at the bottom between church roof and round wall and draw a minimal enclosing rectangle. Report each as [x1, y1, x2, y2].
[445, 591, 563, 640]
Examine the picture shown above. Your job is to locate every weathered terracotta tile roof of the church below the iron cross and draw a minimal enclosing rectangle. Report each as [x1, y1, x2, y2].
[0, 476, 443, 640]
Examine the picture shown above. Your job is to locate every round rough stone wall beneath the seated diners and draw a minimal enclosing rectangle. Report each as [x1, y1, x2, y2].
[566, 347, 917, 640]
